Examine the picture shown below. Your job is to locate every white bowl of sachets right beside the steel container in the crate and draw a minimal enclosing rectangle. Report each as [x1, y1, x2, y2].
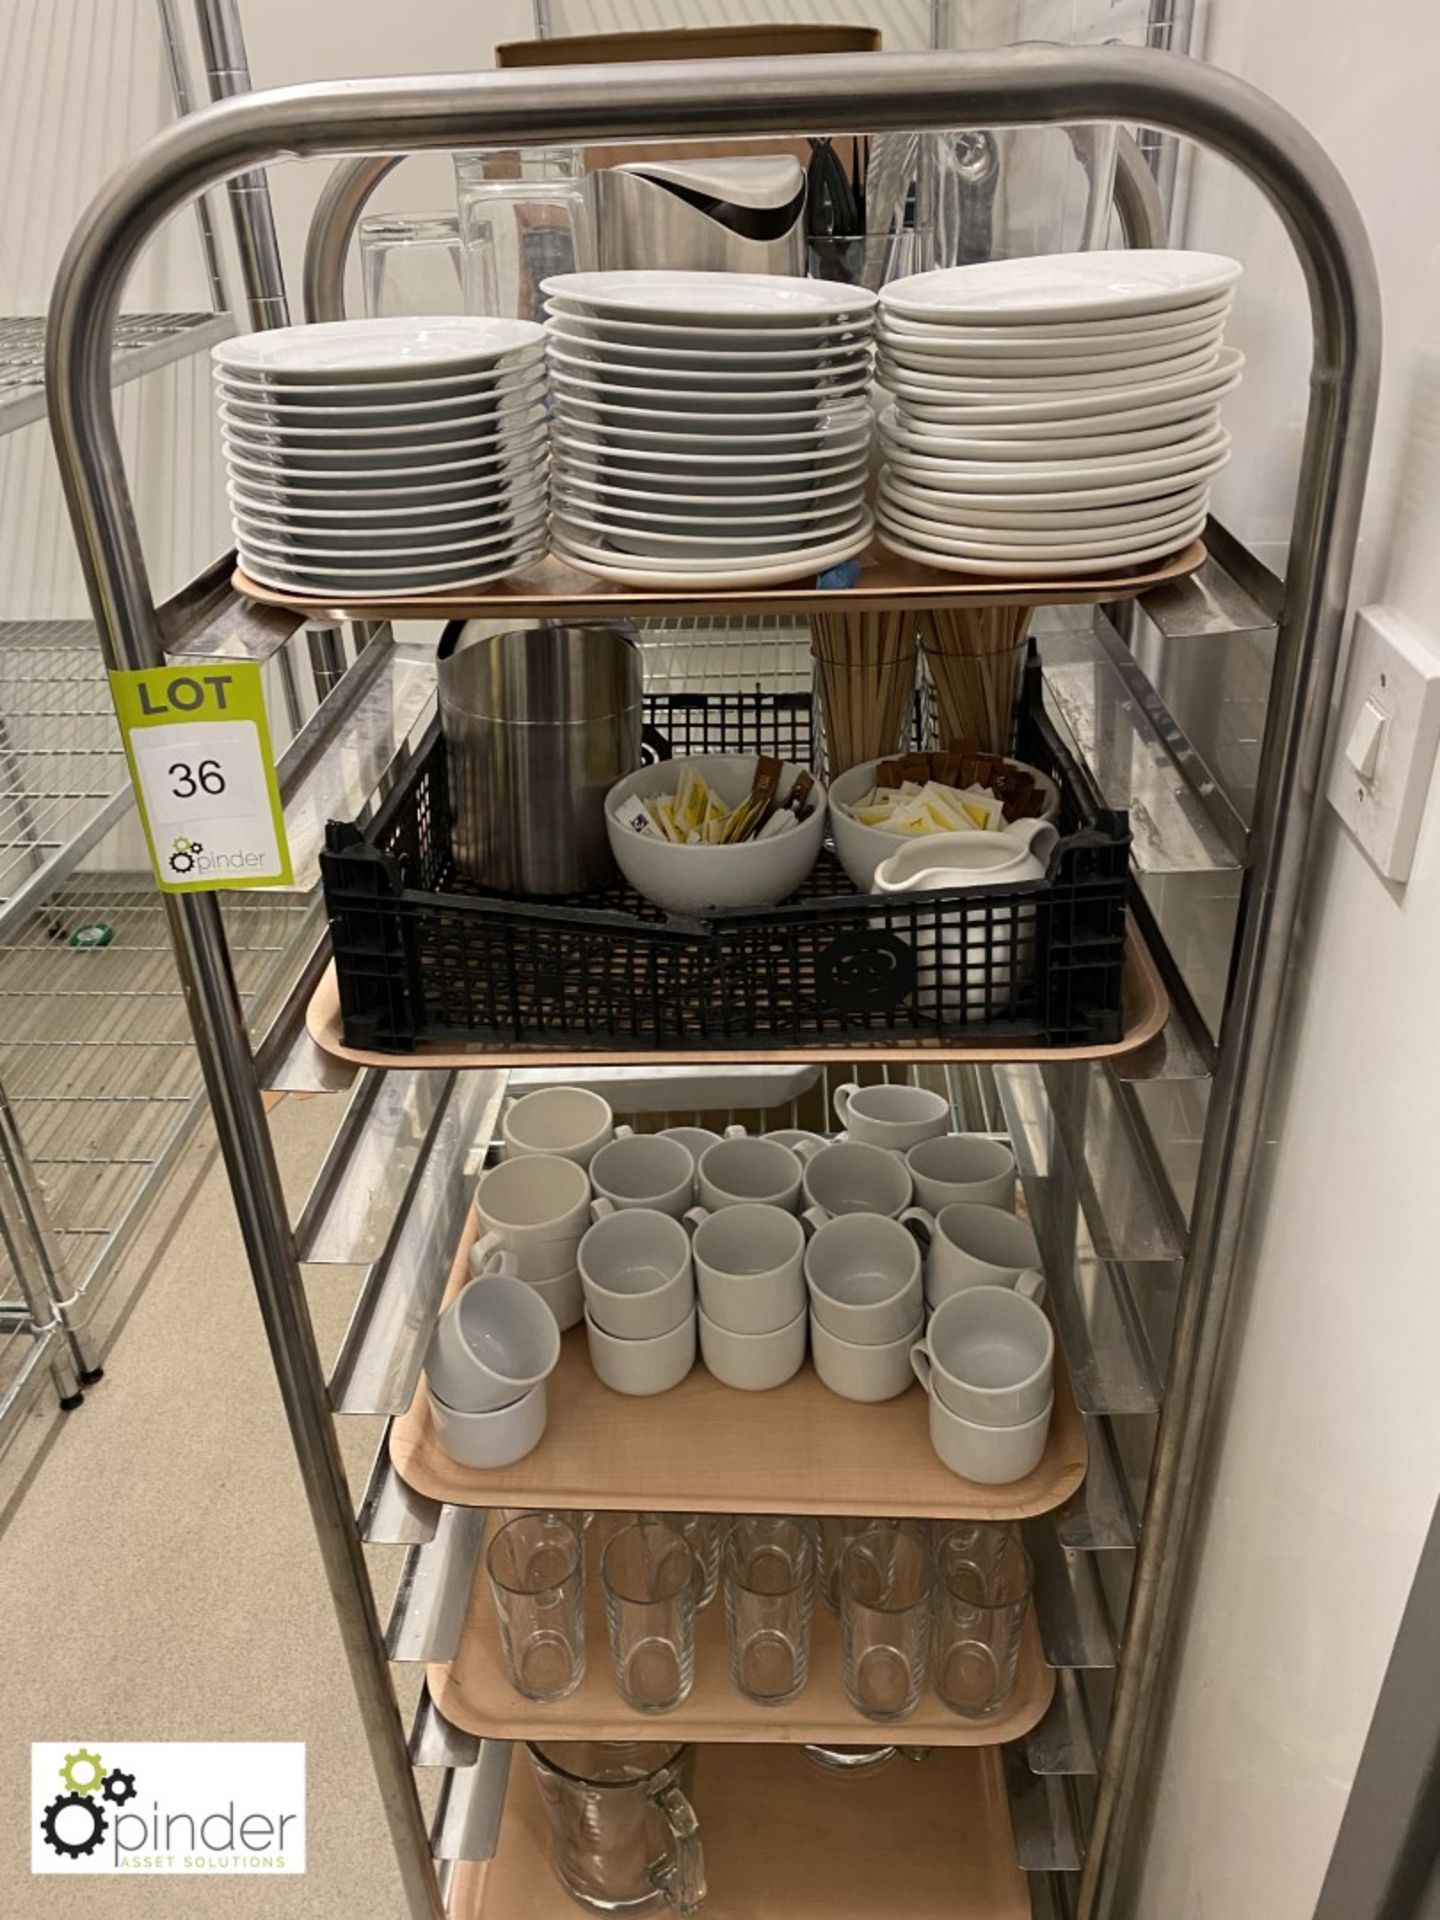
[605, 753, 826, 914]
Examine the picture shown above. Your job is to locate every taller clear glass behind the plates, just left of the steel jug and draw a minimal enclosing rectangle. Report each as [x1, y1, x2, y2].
[455, 146, 593, 321]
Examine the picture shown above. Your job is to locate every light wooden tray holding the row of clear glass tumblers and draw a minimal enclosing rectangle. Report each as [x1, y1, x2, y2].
[428, 1523, 1054, 1747]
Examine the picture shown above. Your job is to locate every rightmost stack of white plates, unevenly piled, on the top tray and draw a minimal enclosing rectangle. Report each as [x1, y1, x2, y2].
[876, 252, 1242, 580]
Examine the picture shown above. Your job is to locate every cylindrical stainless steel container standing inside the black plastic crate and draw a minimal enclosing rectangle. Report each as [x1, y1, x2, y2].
[436, 620, 641, 895]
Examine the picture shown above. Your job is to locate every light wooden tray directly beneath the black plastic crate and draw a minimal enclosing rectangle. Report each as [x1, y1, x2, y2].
[305, 920, 1169, 1068]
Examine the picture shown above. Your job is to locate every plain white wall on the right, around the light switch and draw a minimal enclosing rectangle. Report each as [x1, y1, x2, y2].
[1123, 0, 1440, 1920]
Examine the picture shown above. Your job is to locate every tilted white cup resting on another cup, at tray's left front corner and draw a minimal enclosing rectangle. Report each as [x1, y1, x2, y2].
[424, 1256, 561, 1413]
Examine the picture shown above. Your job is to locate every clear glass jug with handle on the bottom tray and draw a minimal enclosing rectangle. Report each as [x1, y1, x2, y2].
[526, 1740, 705, 1914]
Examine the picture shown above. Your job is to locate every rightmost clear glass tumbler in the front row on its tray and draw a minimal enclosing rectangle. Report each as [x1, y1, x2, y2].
[931, 1526, 1031, 1720]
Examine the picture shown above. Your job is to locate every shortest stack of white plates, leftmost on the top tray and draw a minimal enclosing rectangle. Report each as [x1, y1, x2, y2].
[211, 317, 547, 595]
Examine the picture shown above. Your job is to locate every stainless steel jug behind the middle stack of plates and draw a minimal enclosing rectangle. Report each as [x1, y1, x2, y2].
[589, 154, 804, 273]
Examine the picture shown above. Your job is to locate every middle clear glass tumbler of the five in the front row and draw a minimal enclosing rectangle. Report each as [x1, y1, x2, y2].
[722, 1515, 816, 1707]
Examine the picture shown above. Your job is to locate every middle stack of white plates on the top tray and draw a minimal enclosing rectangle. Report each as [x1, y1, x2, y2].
[543, 271, 876, 588]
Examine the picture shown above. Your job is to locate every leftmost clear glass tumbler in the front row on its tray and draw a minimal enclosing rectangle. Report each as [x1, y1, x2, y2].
[486, 1513, 586, 1701]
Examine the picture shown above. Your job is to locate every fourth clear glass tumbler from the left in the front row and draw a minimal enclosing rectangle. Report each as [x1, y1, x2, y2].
[839, 1521, 931, 1720]
